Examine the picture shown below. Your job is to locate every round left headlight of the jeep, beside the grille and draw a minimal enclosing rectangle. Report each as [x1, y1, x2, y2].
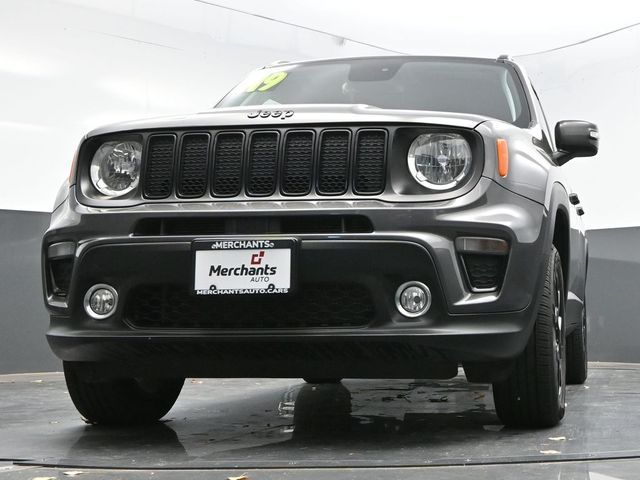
[91, 141, 142, 197]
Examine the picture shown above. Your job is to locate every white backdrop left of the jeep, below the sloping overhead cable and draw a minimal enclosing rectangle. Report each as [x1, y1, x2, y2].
[0, 0, 384, 211]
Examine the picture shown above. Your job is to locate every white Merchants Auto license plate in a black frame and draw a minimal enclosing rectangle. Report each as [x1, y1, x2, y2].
[193, 239, 296, 295]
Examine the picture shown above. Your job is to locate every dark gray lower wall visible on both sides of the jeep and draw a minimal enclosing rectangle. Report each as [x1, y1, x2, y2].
[0, 210, 640, 373]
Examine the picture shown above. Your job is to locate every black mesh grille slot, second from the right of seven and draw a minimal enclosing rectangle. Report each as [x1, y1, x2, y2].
[318, 131, 351, 195]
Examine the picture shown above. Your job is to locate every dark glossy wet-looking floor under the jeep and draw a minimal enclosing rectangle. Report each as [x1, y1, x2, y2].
[0, 364, 640, 480]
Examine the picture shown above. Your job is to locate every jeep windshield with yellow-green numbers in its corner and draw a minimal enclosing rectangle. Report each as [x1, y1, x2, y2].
[217, 57, 529, 127]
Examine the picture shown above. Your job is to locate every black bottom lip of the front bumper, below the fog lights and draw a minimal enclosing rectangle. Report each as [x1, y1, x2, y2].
[48, 326, 527, 382]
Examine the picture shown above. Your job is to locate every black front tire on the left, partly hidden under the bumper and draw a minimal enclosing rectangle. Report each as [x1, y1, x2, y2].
[64, 362, 184, 425]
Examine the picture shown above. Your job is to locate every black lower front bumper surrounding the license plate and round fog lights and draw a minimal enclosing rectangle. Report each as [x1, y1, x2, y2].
[48, 238, 536, 378]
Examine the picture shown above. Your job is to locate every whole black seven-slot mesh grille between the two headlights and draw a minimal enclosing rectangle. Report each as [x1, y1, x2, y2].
[142, 128, 387, 199]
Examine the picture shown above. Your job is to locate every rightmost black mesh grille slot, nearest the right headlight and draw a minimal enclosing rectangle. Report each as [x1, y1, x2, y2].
[353, 130, 387, 194]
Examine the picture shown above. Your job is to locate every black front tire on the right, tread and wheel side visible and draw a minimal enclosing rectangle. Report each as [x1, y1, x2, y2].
[493, 247, 567, 428]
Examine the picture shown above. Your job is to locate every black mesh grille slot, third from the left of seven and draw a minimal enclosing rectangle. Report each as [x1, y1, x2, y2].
[213, 133, 244, 197]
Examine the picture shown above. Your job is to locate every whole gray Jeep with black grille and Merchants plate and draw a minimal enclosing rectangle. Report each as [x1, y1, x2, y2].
[42, 56, 598, 427]
